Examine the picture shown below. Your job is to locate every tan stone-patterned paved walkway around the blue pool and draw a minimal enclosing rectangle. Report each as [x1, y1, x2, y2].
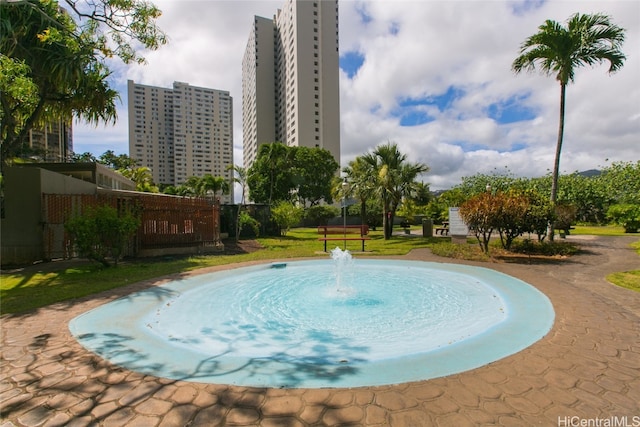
[0, 236, 640, 427]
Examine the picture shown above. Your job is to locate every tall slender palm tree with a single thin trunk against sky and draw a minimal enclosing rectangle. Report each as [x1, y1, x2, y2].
[512, 13, 626, 240]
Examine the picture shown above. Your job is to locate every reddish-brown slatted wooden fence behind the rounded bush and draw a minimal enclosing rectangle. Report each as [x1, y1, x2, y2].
[42, 192, 221, 259]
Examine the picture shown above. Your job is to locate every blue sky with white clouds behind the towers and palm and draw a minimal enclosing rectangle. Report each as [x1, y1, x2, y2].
[73, 0, 640, 190]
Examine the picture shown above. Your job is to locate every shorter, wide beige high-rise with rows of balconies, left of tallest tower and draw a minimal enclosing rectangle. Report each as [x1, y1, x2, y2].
[128, 80, 233, 203]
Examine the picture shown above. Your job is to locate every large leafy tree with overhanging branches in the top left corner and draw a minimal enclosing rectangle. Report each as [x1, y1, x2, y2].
[0, 0, 166, 166]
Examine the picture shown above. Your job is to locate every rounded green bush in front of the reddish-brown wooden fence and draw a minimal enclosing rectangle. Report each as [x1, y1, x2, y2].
[65, 205, 140, 267]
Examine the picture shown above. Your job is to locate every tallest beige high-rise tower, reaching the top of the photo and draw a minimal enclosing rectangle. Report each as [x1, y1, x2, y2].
[242, 0, 340, 168]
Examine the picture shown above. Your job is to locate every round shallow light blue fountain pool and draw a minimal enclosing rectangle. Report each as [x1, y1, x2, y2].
[70, 259, 554, 388]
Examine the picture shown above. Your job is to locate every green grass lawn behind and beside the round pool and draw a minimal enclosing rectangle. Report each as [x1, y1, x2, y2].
[0, 227, 640, 314]
